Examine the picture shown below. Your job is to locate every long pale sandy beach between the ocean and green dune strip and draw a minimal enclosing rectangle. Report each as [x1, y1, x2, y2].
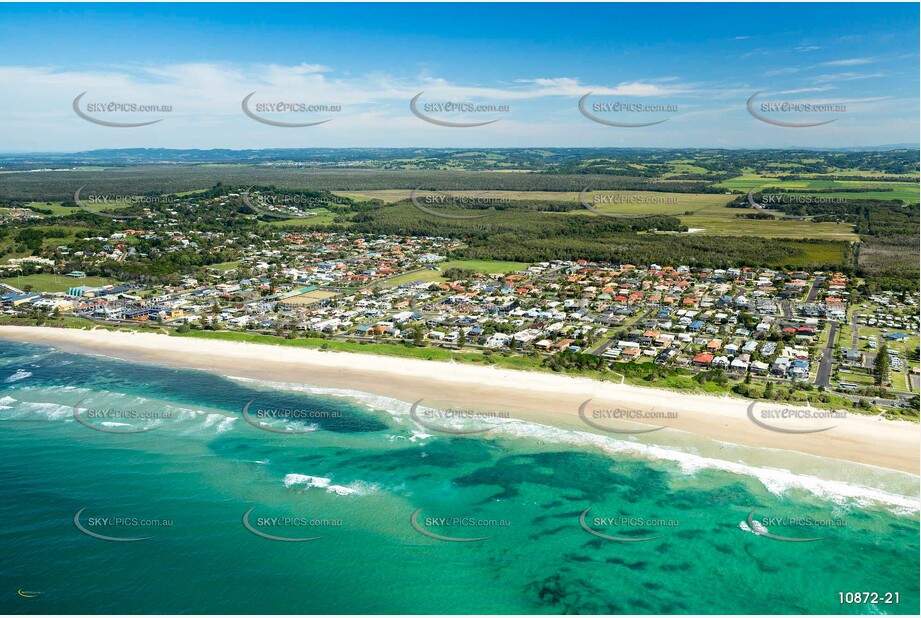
[0, 326, 921, 474]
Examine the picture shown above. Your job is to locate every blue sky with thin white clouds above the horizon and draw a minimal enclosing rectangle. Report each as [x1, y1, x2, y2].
[0, 3, 921, 152]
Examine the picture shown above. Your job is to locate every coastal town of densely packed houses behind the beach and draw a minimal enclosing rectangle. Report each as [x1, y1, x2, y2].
[0, 205, 919, 408]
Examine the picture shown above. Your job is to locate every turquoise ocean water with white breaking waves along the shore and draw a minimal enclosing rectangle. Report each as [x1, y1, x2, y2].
[0, 339, 919, 614]
